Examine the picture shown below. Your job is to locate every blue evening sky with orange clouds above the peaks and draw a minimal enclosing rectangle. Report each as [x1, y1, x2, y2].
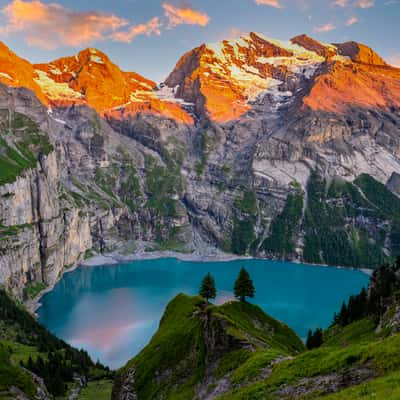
[0, 0, 400, 82]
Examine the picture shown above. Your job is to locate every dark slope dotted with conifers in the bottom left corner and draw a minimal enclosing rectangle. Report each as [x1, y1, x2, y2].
[0, 289, 111, 400]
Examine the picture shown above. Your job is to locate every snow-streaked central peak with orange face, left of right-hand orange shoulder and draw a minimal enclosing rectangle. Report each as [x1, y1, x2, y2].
[165, 32, 333, 122]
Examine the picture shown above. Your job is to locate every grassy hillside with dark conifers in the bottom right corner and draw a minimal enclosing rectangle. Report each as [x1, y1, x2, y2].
[216, 259, 400, 399]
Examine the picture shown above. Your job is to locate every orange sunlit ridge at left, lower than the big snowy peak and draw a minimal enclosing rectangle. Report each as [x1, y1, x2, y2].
[0, 43, 193, 124]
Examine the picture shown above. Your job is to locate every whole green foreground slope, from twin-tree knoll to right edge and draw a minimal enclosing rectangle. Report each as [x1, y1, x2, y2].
[113, 259, 400, 400]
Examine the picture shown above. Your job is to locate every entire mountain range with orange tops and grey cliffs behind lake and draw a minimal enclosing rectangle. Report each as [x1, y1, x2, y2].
[0, 33, 400, 296]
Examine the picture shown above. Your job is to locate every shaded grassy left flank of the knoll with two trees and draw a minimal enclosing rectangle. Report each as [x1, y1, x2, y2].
[121, 294, 205, 399]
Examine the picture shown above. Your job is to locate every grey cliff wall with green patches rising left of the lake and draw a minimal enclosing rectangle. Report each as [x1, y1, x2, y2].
[0, 82, 191, 297]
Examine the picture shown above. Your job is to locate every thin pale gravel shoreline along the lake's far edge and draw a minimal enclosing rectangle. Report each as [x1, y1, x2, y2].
[25, 242, 374, 317]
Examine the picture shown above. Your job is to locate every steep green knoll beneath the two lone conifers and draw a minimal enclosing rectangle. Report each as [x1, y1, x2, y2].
[113, 294, 304, 399]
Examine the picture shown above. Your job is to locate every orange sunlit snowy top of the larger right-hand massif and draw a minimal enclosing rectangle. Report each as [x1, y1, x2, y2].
[166, 33, 400, 123]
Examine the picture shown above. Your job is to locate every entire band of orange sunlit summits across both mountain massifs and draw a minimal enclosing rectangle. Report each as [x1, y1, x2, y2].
[0, 33, 400, 125]
